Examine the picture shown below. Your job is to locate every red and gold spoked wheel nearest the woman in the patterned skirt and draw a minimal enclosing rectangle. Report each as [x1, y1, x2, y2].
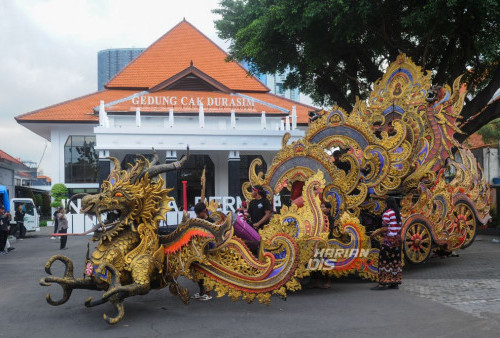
[403, 220, 432, 264]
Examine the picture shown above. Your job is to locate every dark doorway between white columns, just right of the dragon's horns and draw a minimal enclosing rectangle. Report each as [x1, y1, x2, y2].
[177, 155, 215, 207]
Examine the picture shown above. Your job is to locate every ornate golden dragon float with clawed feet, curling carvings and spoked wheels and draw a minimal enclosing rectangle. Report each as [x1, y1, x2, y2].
[40, 55, 490, 324]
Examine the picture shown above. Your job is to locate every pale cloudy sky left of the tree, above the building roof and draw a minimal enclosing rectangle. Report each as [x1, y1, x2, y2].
[0, 0, 240, 176]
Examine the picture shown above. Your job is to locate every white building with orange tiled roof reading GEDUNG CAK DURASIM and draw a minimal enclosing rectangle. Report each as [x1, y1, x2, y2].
[16, 21, 315, 227]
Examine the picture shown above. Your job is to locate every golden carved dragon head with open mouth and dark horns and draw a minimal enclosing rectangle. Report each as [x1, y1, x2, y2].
[82, 148, 189, 241]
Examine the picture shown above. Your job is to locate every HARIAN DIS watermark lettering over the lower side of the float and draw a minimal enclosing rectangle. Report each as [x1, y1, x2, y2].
[307, 248, 370, 271]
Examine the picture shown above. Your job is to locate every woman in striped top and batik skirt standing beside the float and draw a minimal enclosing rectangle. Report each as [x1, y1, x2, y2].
[371, 197, 402, 290]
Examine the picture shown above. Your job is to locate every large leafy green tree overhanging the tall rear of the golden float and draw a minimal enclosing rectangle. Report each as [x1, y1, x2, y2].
[214, 0, 500, 140]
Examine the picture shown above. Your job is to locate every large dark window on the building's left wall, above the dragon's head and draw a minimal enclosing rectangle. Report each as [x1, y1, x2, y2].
[64, 136, 99, 183]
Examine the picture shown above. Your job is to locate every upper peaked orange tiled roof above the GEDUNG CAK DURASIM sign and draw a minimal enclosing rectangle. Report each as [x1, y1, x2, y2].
[106, 20, 269, 92]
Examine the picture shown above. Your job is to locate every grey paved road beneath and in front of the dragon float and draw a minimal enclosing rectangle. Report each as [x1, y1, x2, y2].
[0, 228, 500, 337]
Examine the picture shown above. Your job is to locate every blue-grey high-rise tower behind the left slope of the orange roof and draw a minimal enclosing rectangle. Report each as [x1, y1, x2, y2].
[97, 48, 144, 90]
